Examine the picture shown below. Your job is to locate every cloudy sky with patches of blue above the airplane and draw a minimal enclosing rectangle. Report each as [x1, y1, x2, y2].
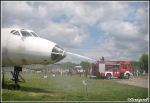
[1, 1, 149, 63]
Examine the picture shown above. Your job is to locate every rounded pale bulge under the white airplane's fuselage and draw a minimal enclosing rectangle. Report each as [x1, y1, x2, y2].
[22, 64, 47, 70]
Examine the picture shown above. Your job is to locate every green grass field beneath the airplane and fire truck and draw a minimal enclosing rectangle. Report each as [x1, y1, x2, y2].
[2, 74, 148, 101]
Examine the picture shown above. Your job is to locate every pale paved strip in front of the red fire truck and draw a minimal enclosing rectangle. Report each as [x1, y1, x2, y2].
[110, 76, 149, 88]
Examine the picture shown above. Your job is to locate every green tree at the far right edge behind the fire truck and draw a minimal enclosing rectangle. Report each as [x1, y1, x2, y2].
[139, 53, 148, 70]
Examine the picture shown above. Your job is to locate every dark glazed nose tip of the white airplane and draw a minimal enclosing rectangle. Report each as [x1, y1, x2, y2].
[51, 45, 66, 63]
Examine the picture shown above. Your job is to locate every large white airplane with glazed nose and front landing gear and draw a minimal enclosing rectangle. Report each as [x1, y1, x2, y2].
[1, 28, 66, 90]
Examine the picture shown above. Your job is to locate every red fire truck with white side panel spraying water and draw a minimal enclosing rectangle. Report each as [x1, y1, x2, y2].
[92, 61, 132, 79]
